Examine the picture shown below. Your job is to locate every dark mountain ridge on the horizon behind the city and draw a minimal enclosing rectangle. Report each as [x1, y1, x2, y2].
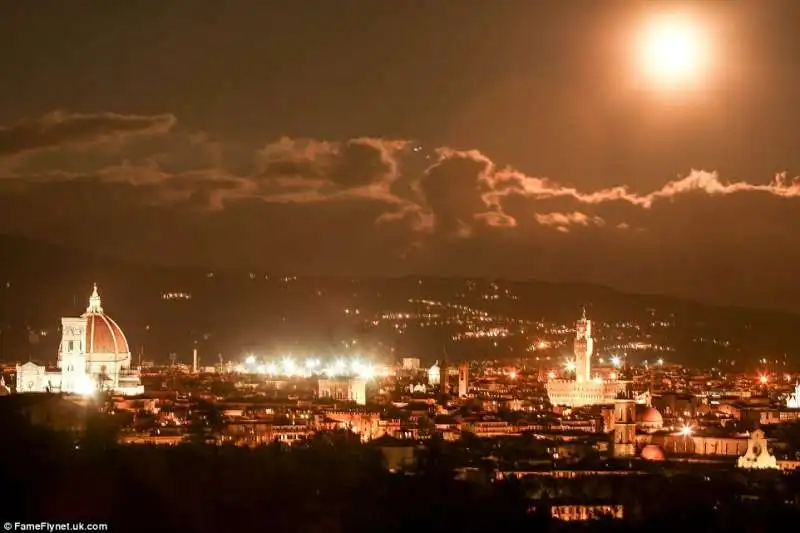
[0, 235, 800, 370]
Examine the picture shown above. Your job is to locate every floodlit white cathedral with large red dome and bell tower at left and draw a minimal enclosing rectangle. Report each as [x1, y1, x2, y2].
[16, 285, 144, 396]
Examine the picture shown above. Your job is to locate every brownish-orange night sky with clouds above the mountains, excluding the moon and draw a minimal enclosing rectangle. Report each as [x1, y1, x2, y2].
[0, 0, 800, 309]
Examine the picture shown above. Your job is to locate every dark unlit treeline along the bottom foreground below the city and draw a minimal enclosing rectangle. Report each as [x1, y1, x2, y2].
[0, 412, 798, 533]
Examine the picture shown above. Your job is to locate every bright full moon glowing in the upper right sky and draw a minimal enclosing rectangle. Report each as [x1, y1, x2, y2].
[639, 15, 707, 86]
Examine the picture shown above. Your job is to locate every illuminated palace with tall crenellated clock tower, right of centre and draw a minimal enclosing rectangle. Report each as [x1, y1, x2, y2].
[547, 311, 625, 407]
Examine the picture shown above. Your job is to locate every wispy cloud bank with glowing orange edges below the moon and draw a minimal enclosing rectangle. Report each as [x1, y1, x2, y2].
[0, 112, 800, 236]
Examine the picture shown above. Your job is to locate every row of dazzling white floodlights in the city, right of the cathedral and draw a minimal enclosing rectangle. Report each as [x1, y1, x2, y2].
[234, 355, 385, 380]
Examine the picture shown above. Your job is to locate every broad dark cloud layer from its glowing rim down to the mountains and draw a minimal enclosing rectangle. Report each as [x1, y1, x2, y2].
[0, 113, 800, 308]
